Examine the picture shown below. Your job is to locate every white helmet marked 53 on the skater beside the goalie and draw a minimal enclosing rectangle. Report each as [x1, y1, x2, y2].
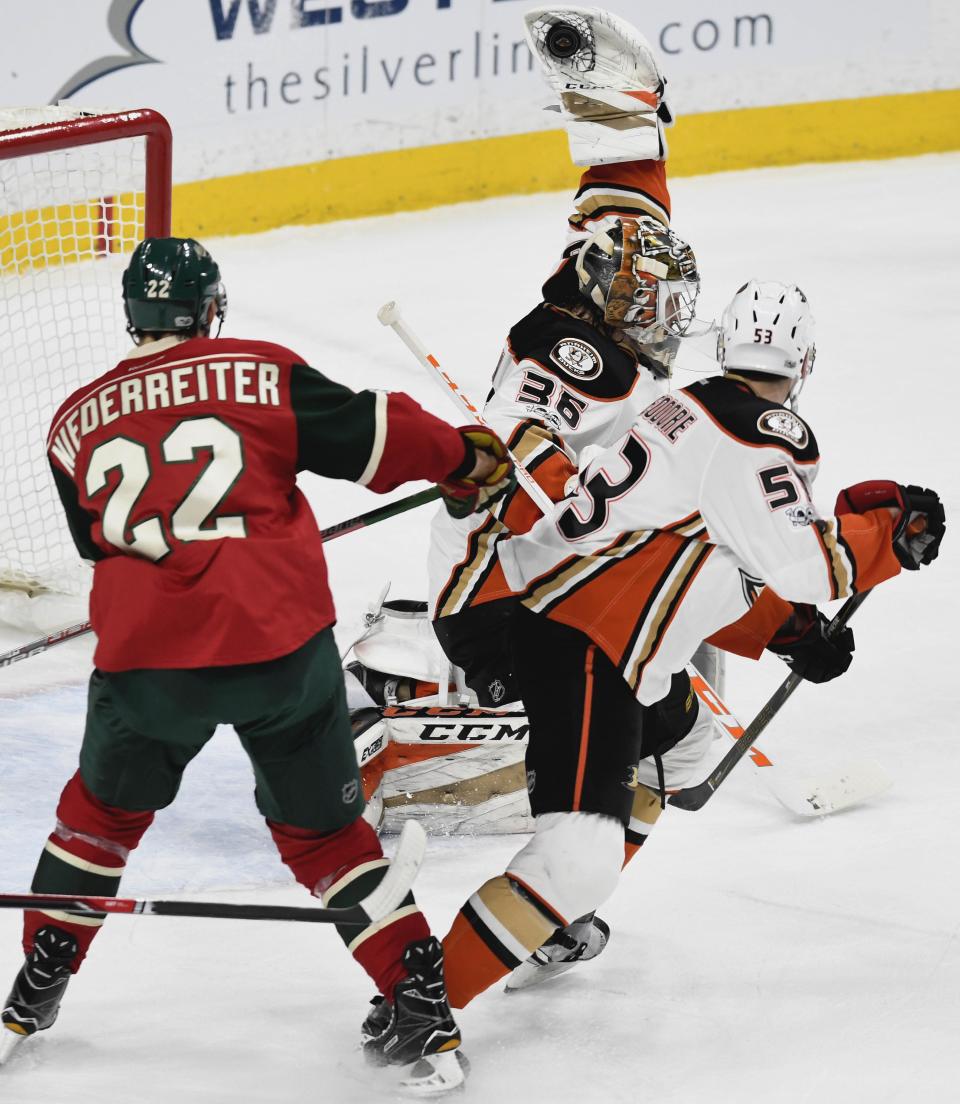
[717, 279, 817, 401]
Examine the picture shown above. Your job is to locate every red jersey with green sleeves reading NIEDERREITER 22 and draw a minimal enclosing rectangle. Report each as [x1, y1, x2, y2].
[47, 338, 465, 671]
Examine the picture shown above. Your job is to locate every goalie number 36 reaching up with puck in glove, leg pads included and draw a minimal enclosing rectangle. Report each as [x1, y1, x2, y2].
[348, 7, 737, 843]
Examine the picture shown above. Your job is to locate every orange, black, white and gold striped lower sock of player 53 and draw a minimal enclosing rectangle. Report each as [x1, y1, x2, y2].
[444, 874, 565, 1008]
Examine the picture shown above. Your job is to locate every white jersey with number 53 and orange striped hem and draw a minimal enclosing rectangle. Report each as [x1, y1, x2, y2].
[498, 376, 900, 704]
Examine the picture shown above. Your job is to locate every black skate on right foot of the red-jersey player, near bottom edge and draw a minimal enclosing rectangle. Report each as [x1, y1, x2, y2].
[360, 936, 469, 1096]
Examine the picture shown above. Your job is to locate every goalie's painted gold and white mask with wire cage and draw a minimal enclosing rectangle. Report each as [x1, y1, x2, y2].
[576, 217, 700, 370]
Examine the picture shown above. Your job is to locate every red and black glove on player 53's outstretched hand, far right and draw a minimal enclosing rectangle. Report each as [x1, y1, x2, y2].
[834, 479, 947, 571]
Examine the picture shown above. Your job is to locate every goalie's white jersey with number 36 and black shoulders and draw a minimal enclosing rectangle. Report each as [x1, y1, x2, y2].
[427, 155, 670, 617]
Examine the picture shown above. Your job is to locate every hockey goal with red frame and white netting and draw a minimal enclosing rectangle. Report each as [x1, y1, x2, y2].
[0, 107, 171, 629]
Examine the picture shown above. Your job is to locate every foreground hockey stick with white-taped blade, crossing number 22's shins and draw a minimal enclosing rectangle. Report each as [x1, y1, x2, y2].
[0, 820, 427, 927]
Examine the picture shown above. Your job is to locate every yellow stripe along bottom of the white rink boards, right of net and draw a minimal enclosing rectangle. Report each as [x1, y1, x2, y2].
[173, 89, 960, 237]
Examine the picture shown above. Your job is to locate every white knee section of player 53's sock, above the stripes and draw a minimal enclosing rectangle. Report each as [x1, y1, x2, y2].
[506, 813, 623, 931]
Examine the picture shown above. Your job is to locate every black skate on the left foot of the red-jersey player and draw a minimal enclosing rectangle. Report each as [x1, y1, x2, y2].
[0, 927, 77, 1065]
